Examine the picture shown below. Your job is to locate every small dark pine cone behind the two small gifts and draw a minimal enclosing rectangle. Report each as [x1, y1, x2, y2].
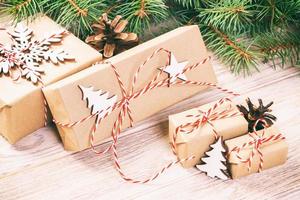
[237, 98, 277, 132]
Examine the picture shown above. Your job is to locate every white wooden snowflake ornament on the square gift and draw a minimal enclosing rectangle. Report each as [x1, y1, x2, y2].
[0, 23, 74, 84]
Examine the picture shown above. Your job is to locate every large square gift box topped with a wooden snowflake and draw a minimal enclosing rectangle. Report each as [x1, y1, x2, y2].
[0, 16, 102, 143]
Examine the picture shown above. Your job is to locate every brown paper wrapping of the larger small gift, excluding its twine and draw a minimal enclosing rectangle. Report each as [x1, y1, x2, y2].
[169, 102, 248, 168]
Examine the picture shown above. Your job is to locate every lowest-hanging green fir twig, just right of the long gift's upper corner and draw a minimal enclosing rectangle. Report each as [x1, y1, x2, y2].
[202, 25, 258, 75]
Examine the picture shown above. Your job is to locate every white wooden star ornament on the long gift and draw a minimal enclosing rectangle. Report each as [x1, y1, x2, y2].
[161, 53, 188, 83]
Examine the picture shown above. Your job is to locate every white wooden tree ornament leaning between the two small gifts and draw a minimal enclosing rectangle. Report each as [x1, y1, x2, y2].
[196, 137, 228, 180]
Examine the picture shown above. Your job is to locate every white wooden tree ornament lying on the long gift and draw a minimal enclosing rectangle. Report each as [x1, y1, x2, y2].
[78, 85, 117, 124]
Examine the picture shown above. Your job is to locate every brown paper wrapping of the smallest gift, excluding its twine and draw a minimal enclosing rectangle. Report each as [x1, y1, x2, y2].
[225, 126, 288, 179]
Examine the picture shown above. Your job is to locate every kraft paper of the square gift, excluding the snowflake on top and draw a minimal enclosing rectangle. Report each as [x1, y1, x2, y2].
[0, 16, 102, 143]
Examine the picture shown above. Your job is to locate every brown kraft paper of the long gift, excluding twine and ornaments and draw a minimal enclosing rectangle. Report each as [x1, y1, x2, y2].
[44, 26, 216, 151]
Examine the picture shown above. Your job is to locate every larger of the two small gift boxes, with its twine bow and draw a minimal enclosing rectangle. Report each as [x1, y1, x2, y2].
[169, 99, 248, 168]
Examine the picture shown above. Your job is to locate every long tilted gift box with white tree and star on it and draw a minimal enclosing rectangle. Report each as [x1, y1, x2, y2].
[44, 26, 216, 151]
